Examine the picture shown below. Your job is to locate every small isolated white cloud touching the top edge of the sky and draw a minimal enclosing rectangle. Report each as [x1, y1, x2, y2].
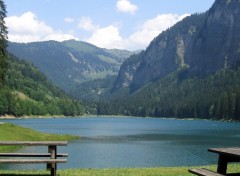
[116, 0, 138, 14]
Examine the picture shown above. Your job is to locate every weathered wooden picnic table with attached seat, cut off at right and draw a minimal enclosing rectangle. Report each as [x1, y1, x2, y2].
[189, 147, 240, 176]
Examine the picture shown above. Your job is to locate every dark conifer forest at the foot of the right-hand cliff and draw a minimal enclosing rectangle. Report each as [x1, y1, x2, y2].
[97, 68, 240, 120]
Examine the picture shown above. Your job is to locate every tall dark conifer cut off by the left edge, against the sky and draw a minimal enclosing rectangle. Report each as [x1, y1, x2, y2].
[0, 0, 8, 86]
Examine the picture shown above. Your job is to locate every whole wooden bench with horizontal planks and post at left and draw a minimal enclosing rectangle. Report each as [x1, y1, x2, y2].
[0, 141, 68, 176]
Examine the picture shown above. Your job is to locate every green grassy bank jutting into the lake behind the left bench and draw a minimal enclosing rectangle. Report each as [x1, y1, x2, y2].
[0, 123, 78, 152]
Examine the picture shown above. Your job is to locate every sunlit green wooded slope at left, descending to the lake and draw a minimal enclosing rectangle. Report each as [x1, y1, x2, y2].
[0, 55, 85, 116]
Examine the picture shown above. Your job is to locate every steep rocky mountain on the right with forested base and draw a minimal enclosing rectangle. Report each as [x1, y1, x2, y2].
[97, 0, 240, 120]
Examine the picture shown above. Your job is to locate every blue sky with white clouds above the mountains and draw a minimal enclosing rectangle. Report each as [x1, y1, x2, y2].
[5, 0, 214, 50]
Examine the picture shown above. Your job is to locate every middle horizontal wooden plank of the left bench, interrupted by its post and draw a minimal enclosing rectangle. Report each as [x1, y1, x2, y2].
[0, 153, 68, 157]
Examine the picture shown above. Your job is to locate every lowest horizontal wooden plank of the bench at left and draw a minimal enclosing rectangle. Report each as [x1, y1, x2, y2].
[0, 159, 67, 164]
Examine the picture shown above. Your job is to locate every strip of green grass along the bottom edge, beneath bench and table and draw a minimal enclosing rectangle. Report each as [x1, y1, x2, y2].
[0, 164, 239, 176]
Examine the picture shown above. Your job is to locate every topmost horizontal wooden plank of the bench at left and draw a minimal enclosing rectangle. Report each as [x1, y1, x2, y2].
[0, 141, 68, 146]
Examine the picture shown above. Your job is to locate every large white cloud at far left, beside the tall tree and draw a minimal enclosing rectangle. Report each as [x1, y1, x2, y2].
[5, 12, 75, 43]
